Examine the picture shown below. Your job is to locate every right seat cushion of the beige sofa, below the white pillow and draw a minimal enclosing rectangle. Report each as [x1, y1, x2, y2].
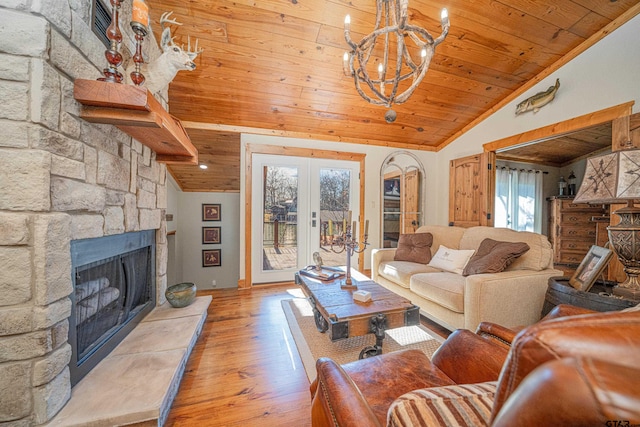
[409, 271, 467, 313]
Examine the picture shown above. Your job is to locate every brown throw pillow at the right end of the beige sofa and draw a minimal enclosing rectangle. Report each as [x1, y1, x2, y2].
[462, 238, 529, 276]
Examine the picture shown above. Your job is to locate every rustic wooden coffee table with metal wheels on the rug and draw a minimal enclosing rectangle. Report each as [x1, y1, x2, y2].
[296, 270, 420, 359]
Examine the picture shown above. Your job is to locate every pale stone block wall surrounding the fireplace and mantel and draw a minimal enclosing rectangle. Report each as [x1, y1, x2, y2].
[0, 0, 167, 426]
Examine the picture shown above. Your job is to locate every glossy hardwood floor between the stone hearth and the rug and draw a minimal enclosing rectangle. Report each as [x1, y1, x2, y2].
[166, 283, 448, 427]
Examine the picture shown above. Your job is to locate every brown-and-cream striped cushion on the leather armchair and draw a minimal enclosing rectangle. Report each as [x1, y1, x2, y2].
[387, 381, 496, 427]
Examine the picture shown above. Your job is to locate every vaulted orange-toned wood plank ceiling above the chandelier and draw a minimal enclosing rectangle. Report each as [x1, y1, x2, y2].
[148, 0, 640, 191]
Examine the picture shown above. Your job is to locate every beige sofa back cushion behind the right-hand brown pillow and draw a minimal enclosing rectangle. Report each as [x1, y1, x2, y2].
[460, 226, 553, 271]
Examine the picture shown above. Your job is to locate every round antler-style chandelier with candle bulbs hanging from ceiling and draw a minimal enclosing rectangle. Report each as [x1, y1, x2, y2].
[343, 0, 449, 123]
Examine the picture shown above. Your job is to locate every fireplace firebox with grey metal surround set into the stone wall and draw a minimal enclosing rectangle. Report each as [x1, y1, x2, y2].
[69, 230, 156, 386]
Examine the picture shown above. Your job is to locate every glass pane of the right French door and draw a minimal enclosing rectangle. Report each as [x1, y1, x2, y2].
[312, 168, 355, 266]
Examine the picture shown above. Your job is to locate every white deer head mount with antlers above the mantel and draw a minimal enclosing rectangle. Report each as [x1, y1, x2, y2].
[126, 12, 204, 93]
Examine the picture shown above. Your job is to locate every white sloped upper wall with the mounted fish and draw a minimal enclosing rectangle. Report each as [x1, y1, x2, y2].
[435, 15, 640, 224]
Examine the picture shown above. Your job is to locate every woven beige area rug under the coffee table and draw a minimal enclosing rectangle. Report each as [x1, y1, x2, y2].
[282, 298, 444, 382]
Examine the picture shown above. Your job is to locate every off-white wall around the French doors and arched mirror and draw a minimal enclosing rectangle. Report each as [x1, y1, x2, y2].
[240, 134, 436, 278]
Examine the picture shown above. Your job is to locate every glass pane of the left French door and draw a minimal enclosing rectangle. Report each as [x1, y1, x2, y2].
[262, 166, 298, 271]
